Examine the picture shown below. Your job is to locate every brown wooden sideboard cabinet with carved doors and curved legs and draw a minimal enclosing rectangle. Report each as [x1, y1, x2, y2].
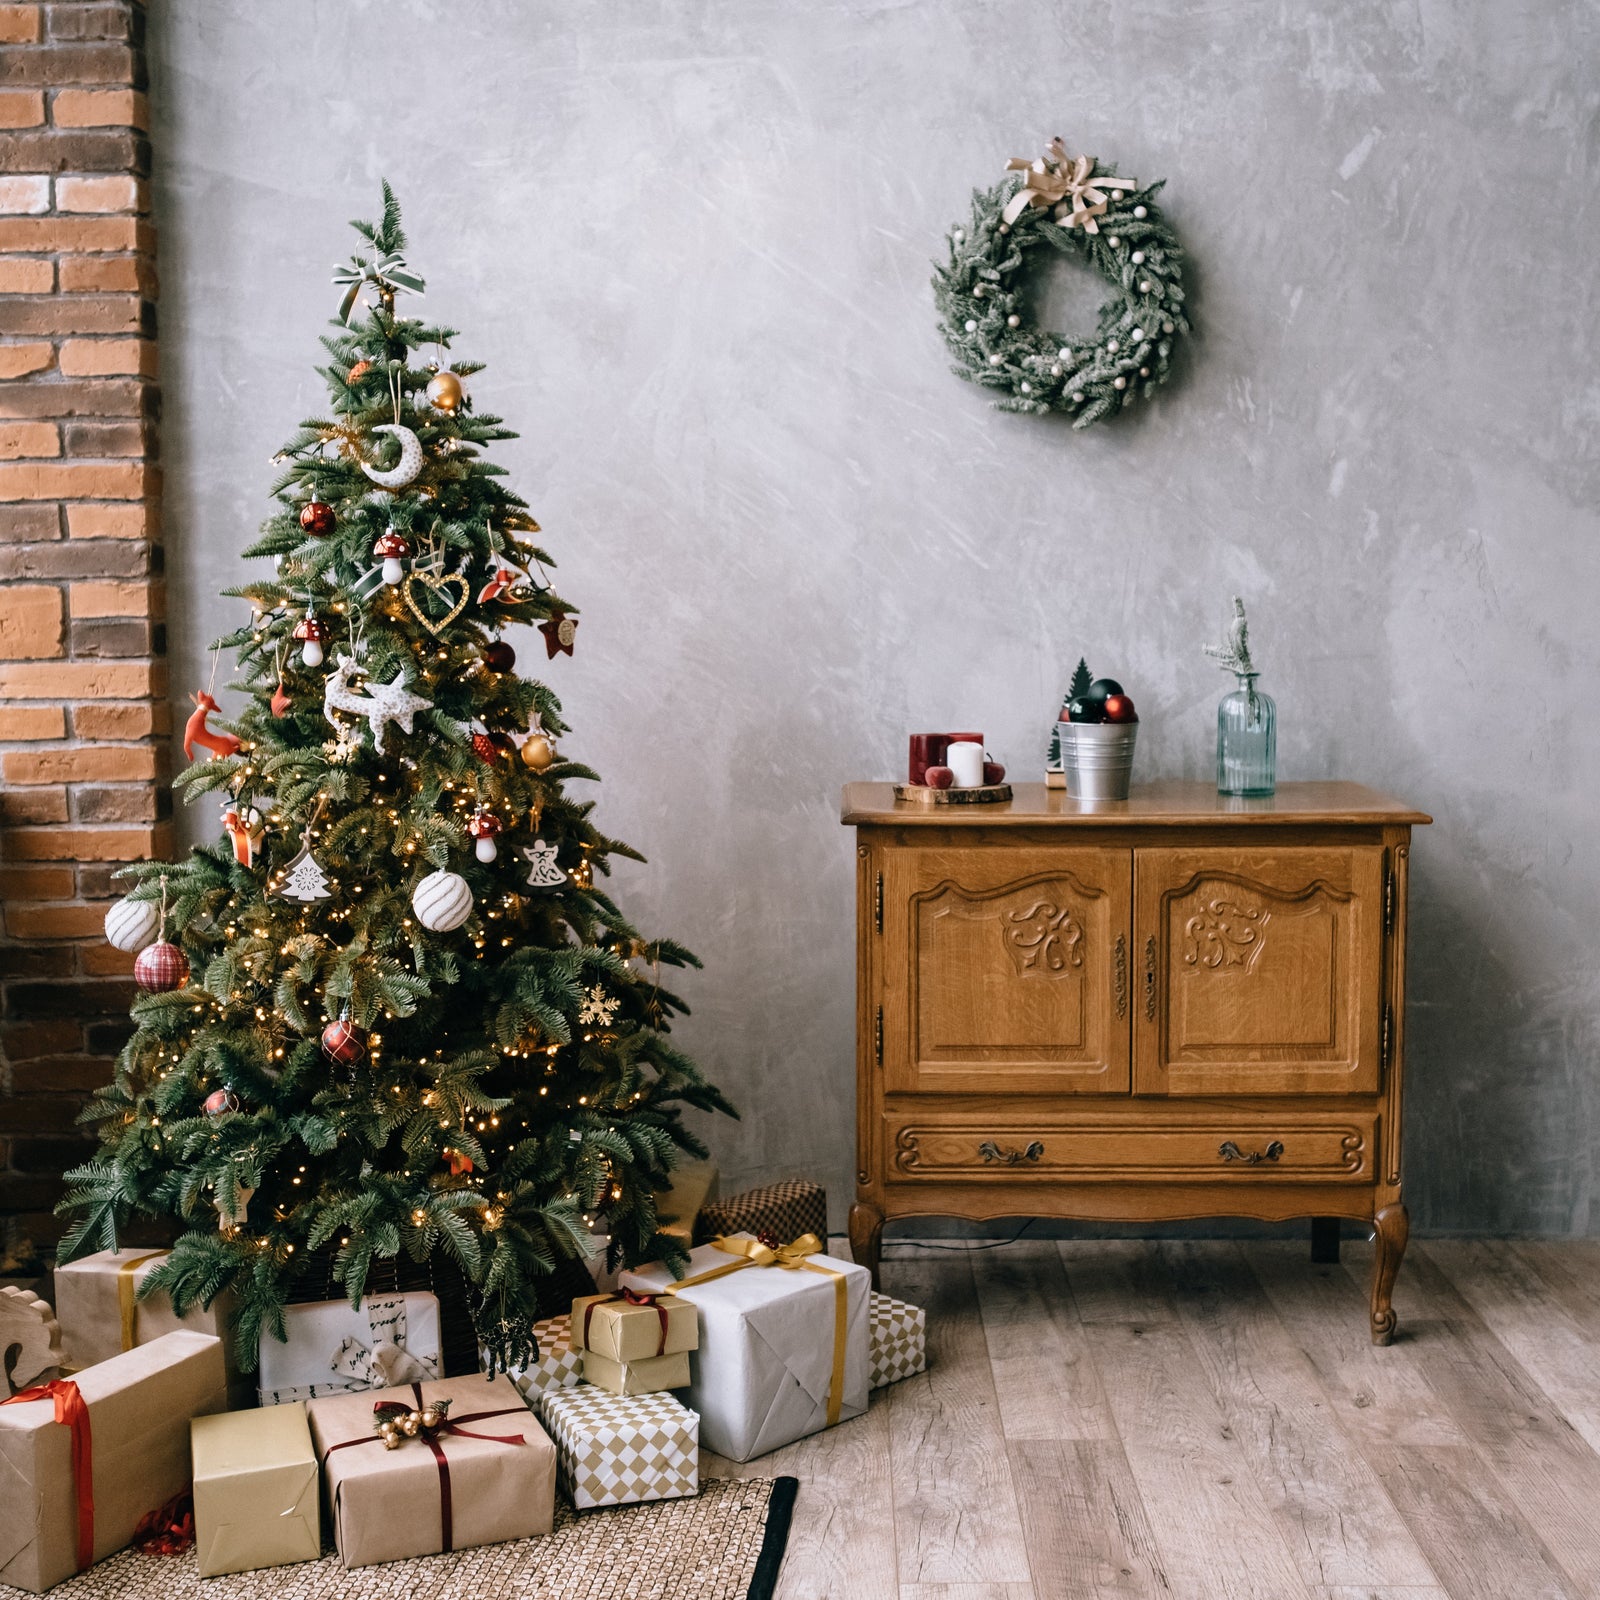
[843, 782, 1430, 1344]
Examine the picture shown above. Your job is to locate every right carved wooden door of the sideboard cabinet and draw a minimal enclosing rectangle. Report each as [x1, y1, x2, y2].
[1133, 845, 1384, 1094]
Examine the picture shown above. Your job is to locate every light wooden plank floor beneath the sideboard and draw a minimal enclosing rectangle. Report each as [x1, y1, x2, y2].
[702, 1240, 1600, 1600]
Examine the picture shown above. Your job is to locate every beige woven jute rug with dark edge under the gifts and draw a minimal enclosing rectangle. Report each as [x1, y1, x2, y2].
[0, 1478, 797, 1600]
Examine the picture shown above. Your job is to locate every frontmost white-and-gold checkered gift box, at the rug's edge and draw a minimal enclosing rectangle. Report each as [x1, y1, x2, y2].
[539, 1384, 699, 1510]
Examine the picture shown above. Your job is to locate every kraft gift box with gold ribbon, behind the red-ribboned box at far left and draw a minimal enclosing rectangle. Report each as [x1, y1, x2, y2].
[56, 1250, 256, 1405]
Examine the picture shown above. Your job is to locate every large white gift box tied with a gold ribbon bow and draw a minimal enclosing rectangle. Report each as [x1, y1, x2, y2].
[622, 1235, 870, 1461]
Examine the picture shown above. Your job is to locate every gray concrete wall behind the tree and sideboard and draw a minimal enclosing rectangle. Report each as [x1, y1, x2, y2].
[150, 0, 1600, 1234]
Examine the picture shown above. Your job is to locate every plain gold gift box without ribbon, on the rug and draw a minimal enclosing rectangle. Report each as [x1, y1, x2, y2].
[189, 1403, 322, 1578]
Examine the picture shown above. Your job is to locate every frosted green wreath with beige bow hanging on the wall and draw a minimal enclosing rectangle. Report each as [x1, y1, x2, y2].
[933, 139, 1189, 427]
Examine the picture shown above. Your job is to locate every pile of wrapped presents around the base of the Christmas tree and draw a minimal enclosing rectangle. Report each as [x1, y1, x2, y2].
[0, 1184, 925, 1592]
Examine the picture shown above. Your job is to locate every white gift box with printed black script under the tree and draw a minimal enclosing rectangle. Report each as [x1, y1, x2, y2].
[259, 1290, 440, 1405]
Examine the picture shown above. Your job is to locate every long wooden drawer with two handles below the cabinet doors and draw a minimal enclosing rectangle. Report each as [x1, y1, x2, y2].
[885, 1110, 1378, 1184]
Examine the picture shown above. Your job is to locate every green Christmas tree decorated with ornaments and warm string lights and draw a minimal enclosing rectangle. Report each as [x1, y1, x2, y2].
[61, 184, 731, 1360]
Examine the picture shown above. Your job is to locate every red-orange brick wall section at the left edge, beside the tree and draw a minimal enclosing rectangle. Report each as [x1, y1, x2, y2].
[0, 0, 170, 1254]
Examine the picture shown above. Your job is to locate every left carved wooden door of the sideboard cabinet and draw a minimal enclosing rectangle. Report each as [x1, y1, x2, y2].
[883, 848, 1133, 1094]
